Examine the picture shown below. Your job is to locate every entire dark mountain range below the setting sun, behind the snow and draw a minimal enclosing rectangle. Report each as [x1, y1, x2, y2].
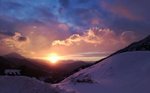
[0, 53, 89, 83]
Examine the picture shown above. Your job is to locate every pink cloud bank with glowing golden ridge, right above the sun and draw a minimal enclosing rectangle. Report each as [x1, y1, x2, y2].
[52, 28, 137, 53]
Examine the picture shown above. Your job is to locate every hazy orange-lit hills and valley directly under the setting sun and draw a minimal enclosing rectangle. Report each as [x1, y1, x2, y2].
[27, 59, 92, 83]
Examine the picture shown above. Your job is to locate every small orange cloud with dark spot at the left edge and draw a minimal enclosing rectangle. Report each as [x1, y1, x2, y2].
[0, 32, 30, 54]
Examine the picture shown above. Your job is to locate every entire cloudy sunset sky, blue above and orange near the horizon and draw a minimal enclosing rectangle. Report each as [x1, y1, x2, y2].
[0, 0, 150, 61]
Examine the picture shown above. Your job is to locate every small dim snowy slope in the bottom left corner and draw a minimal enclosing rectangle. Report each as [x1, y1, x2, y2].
[0, 76, 57, 93]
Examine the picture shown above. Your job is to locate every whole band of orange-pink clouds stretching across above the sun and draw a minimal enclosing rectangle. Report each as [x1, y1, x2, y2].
[0, 26, 136, 58]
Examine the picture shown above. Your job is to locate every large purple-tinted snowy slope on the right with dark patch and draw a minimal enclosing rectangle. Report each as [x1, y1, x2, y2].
[55, 51, 150, 93]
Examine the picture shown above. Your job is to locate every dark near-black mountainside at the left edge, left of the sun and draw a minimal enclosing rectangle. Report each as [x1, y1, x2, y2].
[0, 54, 50, 78]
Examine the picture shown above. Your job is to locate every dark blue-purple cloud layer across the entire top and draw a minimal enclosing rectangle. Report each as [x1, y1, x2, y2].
[0, 0, 150, 34]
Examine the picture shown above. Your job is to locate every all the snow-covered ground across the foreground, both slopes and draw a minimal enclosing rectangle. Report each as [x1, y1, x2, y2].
[0, 51, 150, 93]
